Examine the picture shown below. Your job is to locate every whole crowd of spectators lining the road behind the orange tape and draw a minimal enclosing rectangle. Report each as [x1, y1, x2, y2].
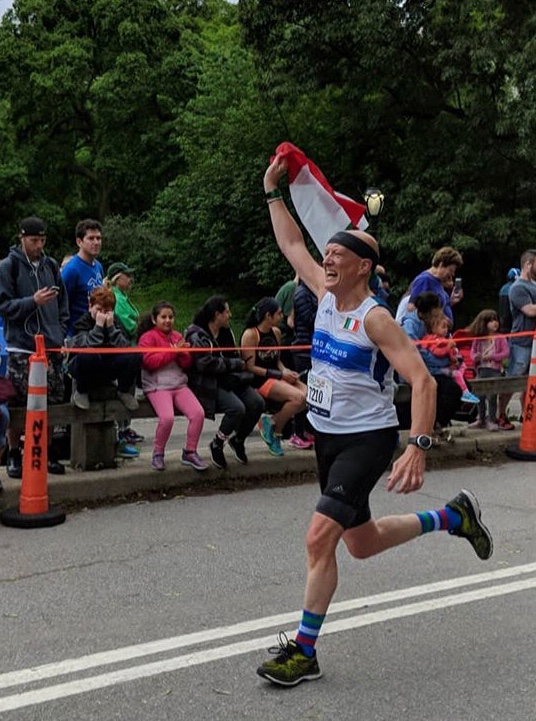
[0, 212, 536, 489]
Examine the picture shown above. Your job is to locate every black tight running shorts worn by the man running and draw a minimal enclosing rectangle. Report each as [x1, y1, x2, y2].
[315, 428, 398, 529]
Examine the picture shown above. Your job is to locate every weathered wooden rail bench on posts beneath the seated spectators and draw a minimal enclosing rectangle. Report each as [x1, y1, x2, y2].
[9, 376, 527, 471]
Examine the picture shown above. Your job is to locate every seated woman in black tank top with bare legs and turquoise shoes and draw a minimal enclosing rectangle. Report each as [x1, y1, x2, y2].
[240, 298, 307, 456]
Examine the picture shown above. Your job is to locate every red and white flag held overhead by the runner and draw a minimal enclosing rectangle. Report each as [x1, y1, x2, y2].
[275, 143, 368, 255]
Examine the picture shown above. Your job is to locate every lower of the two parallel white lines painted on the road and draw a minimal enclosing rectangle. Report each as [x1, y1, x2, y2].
[0, 567, 536, 711]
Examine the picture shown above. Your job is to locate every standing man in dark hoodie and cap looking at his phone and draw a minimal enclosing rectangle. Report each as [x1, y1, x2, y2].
[0, 217, 69, 478]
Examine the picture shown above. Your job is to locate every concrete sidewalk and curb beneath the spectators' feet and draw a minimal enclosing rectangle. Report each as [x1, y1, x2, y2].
[0, 417, 521, 509]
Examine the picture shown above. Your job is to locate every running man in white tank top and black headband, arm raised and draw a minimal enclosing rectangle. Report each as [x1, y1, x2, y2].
[257, 156, 493, 686]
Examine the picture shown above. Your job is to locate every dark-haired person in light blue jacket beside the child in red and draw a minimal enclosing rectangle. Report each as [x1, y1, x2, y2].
[396, 292, 462, 433]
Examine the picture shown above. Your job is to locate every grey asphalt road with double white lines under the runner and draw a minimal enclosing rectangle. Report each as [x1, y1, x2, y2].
[0, 463, 536, 721]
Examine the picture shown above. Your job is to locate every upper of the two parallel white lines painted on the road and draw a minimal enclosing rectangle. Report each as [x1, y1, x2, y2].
[0, 563, 536, 689]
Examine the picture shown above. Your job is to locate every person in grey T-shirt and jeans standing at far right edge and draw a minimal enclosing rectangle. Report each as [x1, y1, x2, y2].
[507, 248, 536, 408]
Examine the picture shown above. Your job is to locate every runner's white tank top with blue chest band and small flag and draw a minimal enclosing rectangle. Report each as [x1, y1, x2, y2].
[307, 293, 398, 433]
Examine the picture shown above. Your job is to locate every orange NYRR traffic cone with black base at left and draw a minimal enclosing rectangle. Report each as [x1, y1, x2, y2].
[0, 335, 65, 528]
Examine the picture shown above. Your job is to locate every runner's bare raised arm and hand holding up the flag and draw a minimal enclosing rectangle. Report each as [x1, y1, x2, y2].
[264, 155, 325, 299]
